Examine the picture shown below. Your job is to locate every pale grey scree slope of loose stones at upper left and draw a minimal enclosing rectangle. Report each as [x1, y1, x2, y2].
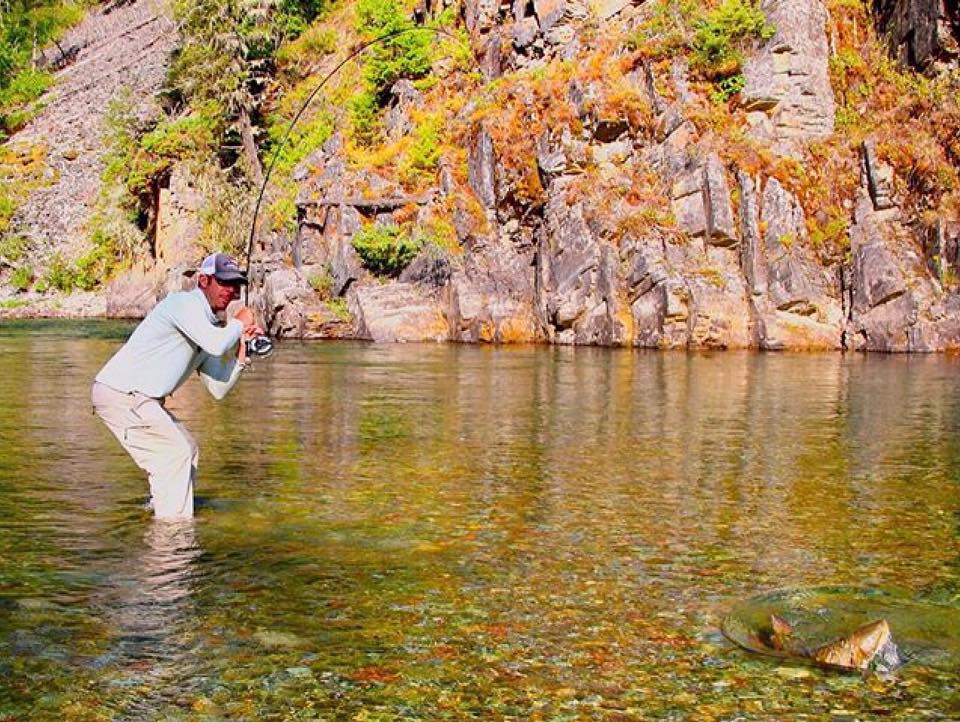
[0, 0, 177, 316]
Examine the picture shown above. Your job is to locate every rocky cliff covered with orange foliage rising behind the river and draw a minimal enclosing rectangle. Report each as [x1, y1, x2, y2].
[1, 0, 960, 351]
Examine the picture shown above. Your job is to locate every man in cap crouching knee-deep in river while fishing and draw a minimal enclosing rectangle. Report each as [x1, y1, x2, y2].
[91, 253, 263, 519]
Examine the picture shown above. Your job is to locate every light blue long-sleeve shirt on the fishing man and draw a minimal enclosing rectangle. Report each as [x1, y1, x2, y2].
[97, 288, 243, 399]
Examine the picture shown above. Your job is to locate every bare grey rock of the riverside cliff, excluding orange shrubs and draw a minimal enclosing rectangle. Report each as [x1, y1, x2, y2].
[232, 0, 960, 351]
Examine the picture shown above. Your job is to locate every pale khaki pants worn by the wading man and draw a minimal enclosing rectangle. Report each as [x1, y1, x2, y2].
[90, 382, 197, 519]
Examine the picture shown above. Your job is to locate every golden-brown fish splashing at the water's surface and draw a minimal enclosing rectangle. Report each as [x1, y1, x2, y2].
[764, 614, 904, 673]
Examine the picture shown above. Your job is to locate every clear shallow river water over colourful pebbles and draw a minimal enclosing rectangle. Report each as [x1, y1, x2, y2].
[0, 323, 960, 721]
